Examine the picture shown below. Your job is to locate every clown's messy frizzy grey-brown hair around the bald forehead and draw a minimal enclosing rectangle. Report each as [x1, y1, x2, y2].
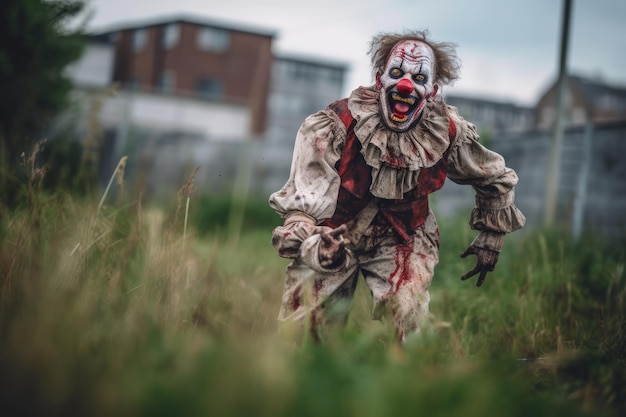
[367, 30, 461, 85]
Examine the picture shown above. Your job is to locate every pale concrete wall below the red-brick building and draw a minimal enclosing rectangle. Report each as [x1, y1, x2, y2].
[66, 89, 254, 198]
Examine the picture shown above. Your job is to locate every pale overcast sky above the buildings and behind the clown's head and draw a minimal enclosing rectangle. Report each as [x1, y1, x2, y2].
[88, 0, 626, 105]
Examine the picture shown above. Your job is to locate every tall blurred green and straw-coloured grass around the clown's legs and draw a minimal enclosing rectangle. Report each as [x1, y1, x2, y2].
[0, 163, 626, 417]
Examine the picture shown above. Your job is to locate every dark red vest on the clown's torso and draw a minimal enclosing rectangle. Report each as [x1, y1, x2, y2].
[323, 98, 456, 240]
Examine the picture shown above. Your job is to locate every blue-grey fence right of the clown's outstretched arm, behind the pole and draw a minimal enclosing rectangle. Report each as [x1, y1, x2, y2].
[491, 121, 626, 239]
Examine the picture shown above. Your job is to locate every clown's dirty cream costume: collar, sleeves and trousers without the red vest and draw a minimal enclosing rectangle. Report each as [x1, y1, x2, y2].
[269, 87, 525, 338]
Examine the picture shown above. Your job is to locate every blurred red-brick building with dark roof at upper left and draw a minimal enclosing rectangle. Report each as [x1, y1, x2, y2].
[94, 16, 275, 135]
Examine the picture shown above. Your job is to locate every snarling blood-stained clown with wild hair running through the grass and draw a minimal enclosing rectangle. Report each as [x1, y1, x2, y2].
[269, 31, 525, 340]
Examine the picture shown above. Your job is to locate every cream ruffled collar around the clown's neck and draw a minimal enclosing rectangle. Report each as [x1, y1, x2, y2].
[348, 87, 450, 199]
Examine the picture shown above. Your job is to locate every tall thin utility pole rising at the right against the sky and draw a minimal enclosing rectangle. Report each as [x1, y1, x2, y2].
[544, 0, 572, 227]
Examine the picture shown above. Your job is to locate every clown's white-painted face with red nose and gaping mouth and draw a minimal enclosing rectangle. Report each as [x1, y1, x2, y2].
[376, 40, 438, 132]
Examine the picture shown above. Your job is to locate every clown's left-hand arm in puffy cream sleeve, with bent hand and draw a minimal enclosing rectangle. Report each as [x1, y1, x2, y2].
[269, 110, 346, 271]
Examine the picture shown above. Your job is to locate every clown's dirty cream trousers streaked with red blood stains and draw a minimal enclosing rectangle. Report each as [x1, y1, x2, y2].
[278, 212, 439, 340]
